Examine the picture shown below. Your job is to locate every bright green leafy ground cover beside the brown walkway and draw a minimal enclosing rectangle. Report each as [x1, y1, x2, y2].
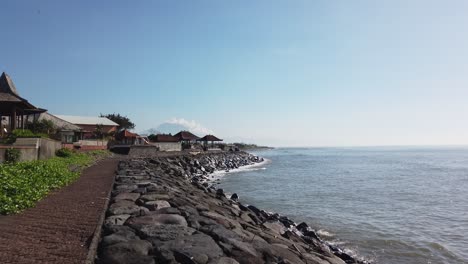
[0, 151, 109, 214]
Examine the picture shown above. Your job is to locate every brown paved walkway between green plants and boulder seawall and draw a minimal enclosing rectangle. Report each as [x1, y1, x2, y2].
[0, 159, 118, 264]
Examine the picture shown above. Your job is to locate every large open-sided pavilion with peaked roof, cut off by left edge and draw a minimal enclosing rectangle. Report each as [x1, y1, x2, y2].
[0, 73, 47, 134]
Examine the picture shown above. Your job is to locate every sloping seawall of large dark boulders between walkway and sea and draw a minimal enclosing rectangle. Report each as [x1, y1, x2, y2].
[96, 152, 366, 264]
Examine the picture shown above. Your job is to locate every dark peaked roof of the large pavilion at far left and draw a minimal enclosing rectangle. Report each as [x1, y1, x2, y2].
[0, 73, 47, 115]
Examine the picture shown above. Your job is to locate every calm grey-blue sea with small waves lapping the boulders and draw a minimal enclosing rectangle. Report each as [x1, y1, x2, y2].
[218, 147, 468, 264]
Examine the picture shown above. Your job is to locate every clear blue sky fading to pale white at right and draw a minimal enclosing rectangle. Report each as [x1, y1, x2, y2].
[0, 0, 468, 146]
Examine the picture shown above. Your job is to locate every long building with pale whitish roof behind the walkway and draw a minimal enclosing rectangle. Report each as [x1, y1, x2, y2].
[55, 115, 119, 139]
